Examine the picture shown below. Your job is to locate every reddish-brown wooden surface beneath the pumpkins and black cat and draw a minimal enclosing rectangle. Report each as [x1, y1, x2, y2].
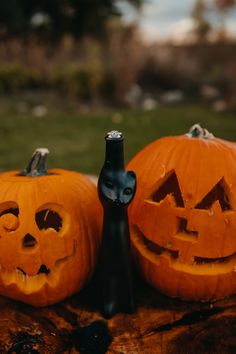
[0, 279, 236, 354]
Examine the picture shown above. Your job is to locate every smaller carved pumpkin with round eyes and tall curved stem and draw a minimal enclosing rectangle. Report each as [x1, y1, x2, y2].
[0, 149, 101, 306]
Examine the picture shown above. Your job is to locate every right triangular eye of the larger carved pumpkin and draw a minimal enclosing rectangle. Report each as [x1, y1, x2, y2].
[195, 178, 231, 211]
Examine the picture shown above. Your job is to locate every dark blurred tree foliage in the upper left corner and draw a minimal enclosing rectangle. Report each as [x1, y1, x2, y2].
[0, 0, 143, 39]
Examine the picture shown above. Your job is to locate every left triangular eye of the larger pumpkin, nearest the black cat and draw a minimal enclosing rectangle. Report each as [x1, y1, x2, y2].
[151, 172, 184, 208]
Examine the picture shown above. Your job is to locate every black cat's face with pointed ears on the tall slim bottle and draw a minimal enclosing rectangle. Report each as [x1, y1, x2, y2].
[98, 168, 136, 206]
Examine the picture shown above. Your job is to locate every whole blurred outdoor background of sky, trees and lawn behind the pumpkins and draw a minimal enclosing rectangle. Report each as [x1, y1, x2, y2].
[0, 0, 236, 174]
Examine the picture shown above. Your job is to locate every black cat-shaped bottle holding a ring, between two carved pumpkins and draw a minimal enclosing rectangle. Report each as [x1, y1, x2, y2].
[98, 131, 136, 318]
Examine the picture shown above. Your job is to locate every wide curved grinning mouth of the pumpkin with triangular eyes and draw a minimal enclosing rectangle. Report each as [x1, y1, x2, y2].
[131, 226, 236, 274]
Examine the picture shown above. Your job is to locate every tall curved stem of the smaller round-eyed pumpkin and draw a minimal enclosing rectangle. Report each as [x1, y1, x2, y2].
[19, 148, 49, 177]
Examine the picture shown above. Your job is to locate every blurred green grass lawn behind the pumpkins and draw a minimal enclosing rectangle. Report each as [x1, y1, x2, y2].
[0, 97, 236, 174]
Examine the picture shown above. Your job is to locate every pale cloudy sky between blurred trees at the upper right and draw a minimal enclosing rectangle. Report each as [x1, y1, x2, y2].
[119, 0, 236, 42]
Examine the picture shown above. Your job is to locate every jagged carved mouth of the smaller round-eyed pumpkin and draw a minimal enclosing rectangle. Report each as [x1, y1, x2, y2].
[0, 243, 75, 294]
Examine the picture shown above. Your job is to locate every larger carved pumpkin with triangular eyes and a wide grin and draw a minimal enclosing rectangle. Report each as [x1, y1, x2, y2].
[128, 125, 236, 300]
